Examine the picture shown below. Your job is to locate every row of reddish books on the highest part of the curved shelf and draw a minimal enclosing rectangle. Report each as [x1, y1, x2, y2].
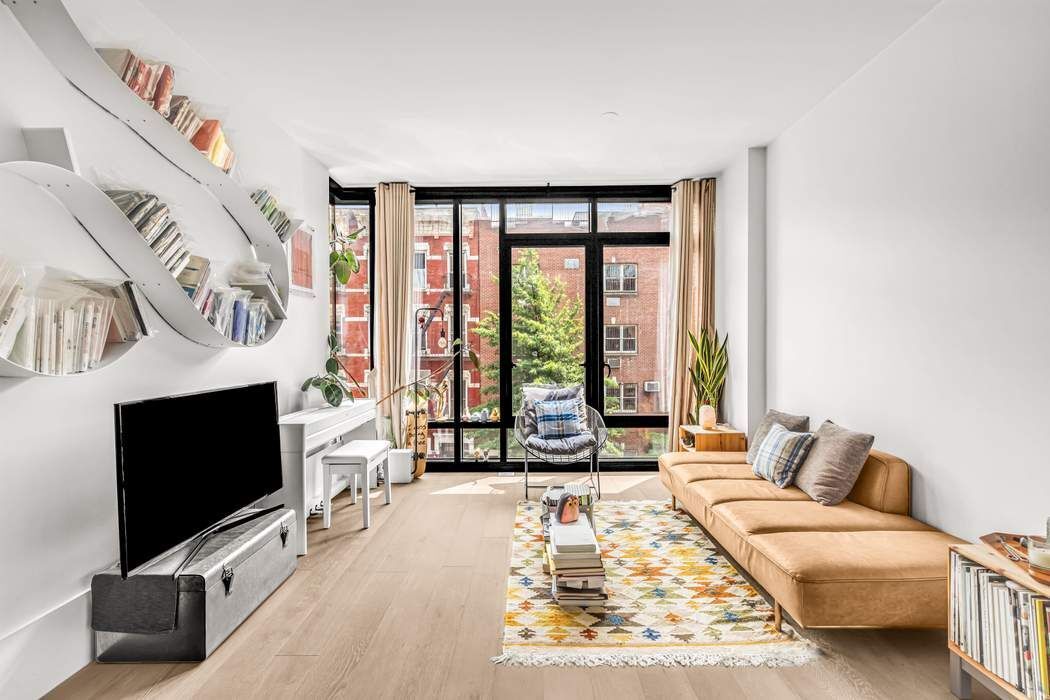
[98, 48, 236, 172]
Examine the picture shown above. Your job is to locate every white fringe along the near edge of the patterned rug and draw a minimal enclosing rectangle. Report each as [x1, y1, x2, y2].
[491, 644, 821, 667]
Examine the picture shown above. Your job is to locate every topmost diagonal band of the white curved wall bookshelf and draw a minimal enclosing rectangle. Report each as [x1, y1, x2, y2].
[2, 0, 289, 314]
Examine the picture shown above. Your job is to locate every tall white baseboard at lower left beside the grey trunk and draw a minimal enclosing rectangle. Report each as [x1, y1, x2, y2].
[0, 591, 92, 700]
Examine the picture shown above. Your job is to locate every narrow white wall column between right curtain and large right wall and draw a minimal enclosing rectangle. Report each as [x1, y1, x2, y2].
[715, 147, 767, 434]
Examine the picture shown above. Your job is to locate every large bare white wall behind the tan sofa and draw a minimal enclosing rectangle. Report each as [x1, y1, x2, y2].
[768, 0, 1050, 538]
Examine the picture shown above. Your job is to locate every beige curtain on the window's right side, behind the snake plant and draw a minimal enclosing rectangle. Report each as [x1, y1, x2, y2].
[667, 178, 715, 451]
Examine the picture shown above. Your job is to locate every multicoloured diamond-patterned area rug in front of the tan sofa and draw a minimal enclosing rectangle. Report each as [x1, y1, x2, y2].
[492, 501, 819, 666]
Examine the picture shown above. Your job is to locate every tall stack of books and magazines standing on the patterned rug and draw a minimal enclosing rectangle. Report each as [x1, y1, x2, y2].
[546, 513, 609, 608]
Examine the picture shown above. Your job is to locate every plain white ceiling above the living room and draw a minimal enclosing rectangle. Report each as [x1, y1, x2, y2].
[137, 0, 937, 186]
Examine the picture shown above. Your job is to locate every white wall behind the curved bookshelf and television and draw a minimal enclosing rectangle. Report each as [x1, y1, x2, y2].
[0, 1, 328, 698]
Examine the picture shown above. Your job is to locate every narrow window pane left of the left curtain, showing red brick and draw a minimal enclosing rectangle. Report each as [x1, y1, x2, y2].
[332, 205, 372, 386]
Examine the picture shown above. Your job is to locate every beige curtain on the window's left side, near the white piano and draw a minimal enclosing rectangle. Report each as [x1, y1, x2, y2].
[373, 183, 416, 444]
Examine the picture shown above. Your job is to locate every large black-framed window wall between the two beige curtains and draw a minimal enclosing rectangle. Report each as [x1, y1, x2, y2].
[329, 186, 671, 469]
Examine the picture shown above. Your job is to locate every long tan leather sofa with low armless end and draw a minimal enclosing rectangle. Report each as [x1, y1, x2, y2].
[659, 450, 962, 628]
